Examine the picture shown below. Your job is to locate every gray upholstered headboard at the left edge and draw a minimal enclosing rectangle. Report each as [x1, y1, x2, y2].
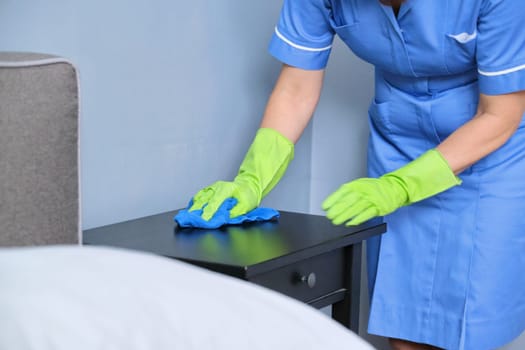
[0, 52, 81, 246]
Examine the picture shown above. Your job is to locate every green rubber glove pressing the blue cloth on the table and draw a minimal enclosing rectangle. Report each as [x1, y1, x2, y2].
[189, 128, 294, 220]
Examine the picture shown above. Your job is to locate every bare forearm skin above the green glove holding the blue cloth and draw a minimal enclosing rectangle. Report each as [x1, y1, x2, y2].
[261, 65, 324, 143]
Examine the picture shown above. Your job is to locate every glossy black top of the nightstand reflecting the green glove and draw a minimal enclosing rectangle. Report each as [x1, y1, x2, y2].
[83, 210, 386, 274]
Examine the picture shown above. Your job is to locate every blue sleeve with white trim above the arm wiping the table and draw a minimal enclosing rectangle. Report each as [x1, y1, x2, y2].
[269, 0, 334, 70]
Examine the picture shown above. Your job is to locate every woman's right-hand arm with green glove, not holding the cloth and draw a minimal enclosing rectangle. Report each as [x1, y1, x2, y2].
[323, 91, 525, 225]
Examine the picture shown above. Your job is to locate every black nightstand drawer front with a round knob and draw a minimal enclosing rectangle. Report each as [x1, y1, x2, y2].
[250, 249, 344, 302]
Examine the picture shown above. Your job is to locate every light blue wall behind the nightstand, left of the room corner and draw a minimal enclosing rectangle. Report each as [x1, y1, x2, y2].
[0, 0, 311, 229]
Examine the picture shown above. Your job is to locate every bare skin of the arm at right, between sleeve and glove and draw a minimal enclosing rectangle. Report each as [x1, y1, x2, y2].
[437, 91, 525, 174]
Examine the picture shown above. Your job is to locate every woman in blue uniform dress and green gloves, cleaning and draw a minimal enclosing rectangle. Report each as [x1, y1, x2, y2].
[188, 0, 525, 350]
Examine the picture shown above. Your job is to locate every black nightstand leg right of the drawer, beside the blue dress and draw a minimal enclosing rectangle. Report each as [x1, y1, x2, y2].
[332, 243, 362, 333]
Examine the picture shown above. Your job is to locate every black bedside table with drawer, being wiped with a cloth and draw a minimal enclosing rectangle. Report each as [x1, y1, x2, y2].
[83, 211, 386, 332]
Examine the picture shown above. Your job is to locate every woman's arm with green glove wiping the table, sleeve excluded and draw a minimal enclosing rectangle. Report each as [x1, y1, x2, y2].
[184, 65, 324, 220]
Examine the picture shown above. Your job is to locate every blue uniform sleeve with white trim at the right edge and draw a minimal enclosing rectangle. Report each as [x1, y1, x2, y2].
[476, 0, 525, 95]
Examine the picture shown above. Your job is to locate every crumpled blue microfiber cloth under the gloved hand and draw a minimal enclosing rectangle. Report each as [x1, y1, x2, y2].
[174, 198, 279, 229]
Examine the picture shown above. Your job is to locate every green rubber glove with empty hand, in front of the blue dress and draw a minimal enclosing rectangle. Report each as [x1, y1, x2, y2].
[322, 149, 461, 226]
